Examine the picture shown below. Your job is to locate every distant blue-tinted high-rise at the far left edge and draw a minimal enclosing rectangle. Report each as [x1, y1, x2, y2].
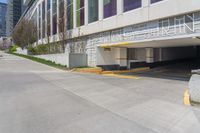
[0, 2, 7, 37]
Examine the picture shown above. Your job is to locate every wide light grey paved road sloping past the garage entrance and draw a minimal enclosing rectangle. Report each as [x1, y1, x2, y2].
[0, 52, 200, 133]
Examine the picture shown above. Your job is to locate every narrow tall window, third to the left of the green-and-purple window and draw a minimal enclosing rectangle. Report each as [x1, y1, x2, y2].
[52, 0, 57, 35]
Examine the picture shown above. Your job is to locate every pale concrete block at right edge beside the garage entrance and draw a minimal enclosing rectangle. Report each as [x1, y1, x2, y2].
[189, 70, 200, 103]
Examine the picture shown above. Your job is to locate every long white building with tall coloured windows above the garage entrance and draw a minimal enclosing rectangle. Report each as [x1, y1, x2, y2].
[17, 0, 200, 69]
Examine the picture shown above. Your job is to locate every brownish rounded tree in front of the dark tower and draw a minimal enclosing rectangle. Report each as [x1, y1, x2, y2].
[12, 19, 37, 48]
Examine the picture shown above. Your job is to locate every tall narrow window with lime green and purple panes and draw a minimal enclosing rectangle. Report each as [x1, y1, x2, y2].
[76, 0, 85, 27]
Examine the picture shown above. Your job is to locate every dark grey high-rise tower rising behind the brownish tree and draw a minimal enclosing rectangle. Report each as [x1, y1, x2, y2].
[6, 0, 22, 36]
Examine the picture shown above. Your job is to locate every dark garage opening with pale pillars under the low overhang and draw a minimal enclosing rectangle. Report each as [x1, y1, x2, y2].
[127, 46, 200, 80]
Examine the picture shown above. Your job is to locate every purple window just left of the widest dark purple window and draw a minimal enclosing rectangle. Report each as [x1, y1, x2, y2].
[103, 0, 117, 18]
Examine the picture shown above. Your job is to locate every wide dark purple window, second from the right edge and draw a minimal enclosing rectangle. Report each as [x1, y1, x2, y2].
[124, 0, 142, 12]
